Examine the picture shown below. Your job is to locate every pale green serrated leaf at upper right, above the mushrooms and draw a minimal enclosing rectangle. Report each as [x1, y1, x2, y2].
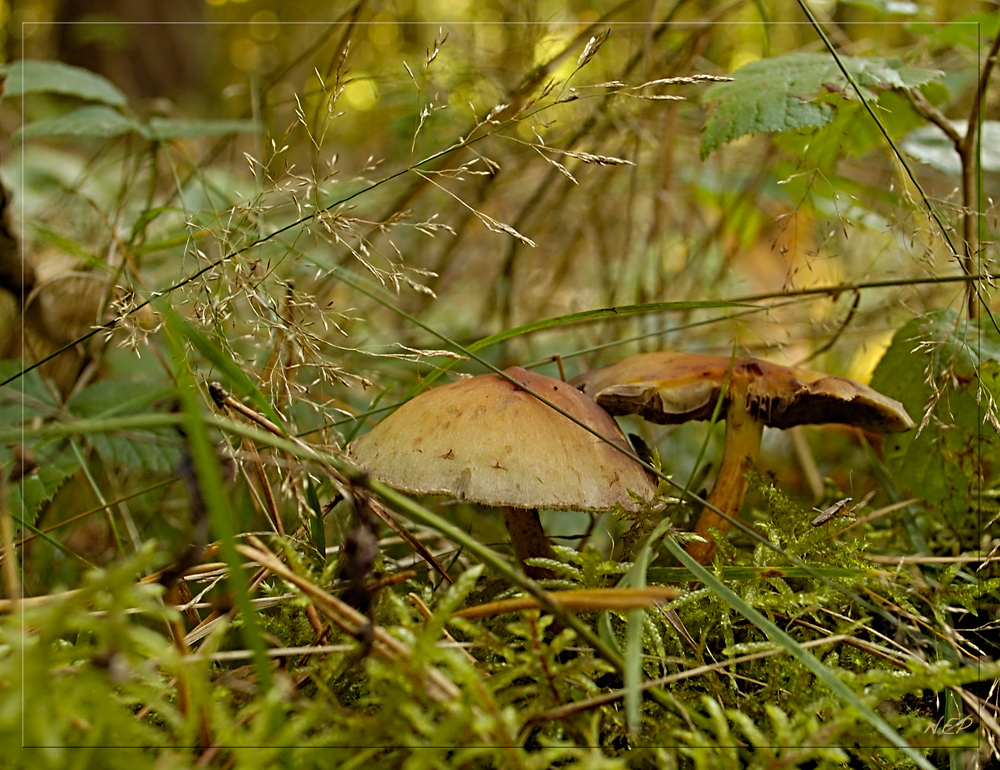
[701, 53, 943, 158]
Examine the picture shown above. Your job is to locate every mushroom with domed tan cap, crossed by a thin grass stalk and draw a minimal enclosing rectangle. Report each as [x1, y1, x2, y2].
[348, 367, 655, 577]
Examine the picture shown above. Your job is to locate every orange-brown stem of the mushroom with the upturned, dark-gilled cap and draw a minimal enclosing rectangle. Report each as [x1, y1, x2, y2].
[687, 383, 764, 564]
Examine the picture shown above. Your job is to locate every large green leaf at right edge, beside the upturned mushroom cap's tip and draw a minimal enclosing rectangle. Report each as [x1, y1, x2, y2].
[871, 310, 1000, 526]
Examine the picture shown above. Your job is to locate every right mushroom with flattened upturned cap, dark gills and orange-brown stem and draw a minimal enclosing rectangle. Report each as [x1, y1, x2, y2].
[571, 352, 913, 564]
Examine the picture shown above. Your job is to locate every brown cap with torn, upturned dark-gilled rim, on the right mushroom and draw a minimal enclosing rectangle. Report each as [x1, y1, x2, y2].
[571, 352, 913, 433]
